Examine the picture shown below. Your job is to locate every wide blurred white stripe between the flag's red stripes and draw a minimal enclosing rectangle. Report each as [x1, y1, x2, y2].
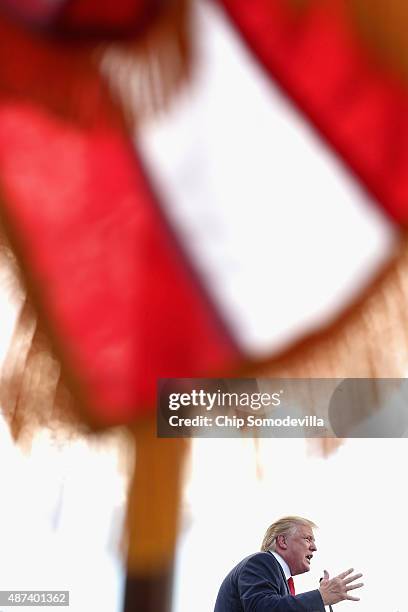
[140, 5, 394, 355]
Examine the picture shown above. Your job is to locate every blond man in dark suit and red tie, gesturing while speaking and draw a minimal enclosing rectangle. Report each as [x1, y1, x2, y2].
[214, 516, 363, 612]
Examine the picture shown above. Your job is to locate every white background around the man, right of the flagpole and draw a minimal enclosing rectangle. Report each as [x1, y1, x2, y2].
[175, 439, 408, 612]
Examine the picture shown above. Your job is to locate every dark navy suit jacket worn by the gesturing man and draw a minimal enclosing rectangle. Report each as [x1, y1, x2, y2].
[214, 552, 324, 612]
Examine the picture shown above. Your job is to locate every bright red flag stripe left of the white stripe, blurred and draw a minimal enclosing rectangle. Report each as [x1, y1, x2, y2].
[0, 105, 239, 424]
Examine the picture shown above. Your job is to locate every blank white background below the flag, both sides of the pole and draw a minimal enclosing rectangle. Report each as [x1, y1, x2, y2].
[0, 428, 408, 612]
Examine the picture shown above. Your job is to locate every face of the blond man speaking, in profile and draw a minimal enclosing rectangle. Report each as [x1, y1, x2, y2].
[277, 525, 317, 576]
